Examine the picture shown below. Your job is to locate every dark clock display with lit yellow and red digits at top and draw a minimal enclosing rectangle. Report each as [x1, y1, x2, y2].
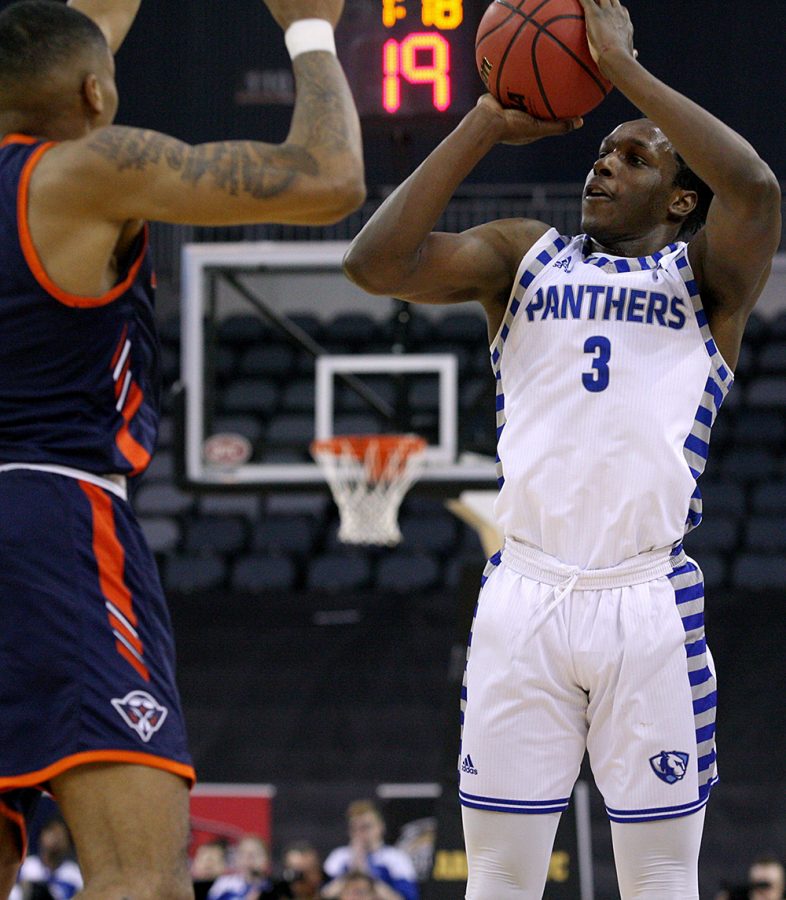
[336, 0, 486, 121]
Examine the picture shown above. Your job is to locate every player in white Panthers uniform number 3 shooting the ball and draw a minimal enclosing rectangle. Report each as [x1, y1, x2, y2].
[345, 0, 781, 900]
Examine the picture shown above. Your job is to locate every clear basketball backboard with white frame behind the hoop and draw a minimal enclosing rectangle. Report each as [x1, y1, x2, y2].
[181, 241, 496, 490]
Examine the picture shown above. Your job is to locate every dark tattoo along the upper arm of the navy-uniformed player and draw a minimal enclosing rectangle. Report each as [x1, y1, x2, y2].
[88, 126, 319, 200]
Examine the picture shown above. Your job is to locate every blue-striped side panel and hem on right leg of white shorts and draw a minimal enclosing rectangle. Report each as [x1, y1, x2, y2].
[606, 560, 718, 822]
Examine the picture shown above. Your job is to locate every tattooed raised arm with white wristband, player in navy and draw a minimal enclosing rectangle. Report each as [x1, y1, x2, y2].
[49, 0, 365, 225]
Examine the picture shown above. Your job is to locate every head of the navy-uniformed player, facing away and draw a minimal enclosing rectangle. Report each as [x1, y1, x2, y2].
[0, 0, 117, 140]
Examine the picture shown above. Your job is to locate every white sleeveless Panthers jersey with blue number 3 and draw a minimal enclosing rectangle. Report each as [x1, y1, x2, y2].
[491, 229, 733, 569]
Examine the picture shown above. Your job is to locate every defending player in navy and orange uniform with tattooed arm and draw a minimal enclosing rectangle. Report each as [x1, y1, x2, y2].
[0, 0, 364, 900]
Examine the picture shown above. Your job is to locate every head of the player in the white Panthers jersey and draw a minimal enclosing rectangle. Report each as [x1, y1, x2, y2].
[581, 119, 712, 246]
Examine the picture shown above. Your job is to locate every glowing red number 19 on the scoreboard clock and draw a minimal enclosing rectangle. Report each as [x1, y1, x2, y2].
[382, 32, 450, 113]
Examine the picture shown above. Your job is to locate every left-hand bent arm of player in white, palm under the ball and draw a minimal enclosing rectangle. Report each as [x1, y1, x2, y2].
[344, 94, 581, 318]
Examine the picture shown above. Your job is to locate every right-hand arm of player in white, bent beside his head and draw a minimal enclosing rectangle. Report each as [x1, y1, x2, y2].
[581, 0, 781, 360]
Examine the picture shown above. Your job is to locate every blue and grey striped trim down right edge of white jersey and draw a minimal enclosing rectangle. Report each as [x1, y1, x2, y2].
[676, 247, 734, 534]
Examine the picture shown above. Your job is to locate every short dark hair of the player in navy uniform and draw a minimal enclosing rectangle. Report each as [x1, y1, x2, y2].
[0, 0, 107, 87]
